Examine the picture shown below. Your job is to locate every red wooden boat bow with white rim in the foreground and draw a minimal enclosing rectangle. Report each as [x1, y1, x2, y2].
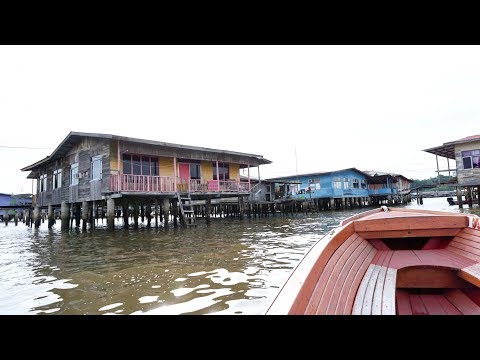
[266, 206, 480, 315]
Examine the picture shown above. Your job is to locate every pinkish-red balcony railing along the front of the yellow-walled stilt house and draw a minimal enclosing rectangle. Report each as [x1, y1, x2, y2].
[110, 174, 249, 193]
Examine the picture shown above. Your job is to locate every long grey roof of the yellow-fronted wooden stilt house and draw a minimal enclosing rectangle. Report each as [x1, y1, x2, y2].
[21, 131, 272, 171]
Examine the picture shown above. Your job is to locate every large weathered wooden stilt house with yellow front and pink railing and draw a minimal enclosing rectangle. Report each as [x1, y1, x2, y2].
[22, 132, 271, 229]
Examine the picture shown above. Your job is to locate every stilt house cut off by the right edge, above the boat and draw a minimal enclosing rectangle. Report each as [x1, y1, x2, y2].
[423, 135, 480, 207]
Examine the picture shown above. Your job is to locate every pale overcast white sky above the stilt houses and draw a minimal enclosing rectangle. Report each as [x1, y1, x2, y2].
[0, 46, 480, 193]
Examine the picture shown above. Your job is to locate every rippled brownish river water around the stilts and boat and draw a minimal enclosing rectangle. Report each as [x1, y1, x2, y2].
[0, 198, 479, 314]
